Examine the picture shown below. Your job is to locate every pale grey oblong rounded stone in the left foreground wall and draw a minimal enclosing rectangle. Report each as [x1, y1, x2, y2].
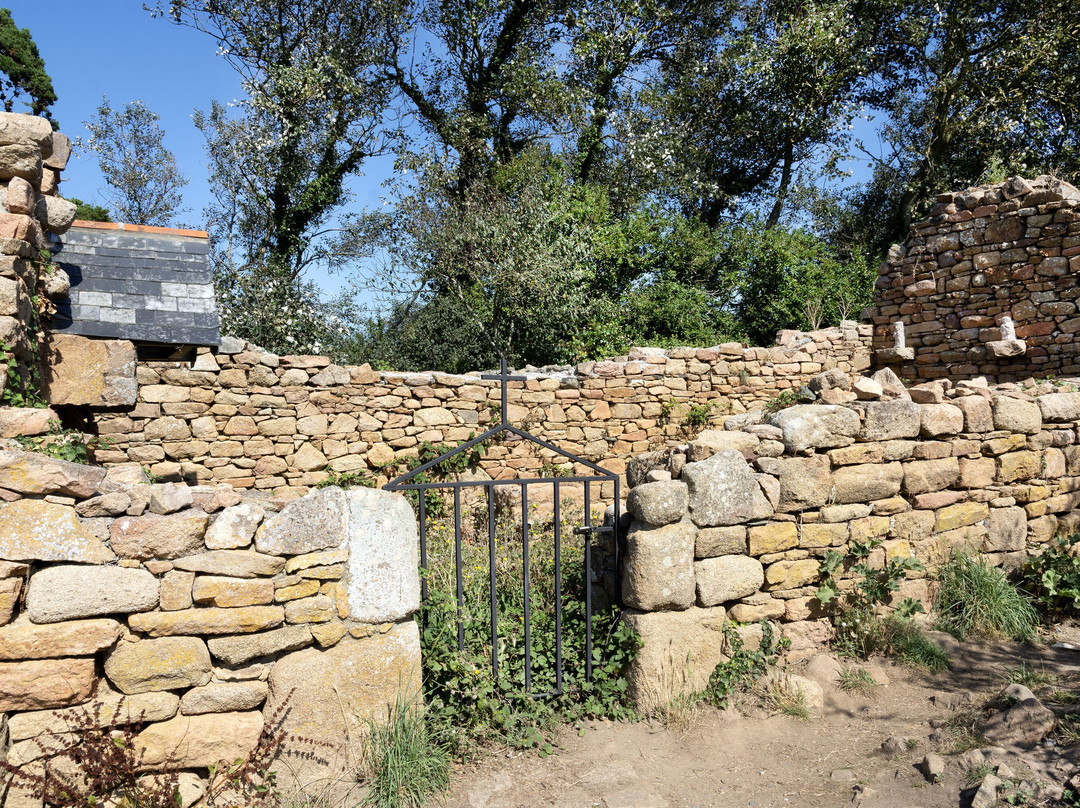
[26, 565, 159, 623]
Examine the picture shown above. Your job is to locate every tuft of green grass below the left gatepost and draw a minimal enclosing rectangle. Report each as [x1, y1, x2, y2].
[361, 692, 450, 808]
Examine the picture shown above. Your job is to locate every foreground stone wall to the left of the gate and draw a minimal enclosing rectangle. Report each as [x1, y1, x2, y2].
[0, 449, 420, 806]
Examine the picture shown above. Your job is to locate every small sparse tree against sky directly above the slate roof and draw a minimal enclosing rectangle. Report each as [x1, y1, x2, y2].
[83, 96, 188, 227]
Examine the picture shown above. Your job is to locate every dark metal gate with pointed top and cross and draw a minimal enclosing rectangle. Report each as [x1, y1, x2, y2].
[383, 360, 619, 697]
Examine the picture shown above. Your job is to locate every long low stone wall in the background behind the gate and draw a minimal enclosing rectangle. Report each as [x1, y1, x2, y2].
[82, 323, 869, 497]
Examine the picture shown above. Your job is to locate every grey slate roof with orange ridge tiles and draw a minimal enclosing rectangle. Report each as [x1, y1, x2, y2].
[50, 220, 221, 346]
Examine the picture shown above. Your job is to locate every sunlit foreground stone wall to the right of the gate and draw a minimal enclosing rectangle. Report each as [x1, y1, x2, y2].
[622, 371, 1080, 709]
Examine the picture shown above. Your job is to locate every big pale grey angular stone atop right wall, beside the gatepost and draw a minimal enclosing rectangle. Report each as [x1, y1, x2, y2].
[680, 450, 772, 527]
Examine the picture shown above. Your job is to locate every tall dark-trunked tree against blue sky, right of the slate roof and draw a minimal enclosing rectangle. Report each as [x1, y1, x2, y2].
[153, 0, 400, 282]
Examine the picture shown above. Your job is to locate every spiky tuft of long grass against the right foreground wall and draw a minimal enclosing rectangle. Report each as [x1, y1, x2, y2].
[934, 552, 1039, 642]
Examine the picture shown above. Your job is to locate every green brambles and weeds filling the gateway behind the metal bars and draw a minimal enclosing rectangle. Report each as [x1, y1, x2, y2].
[421, 502, 640, 756]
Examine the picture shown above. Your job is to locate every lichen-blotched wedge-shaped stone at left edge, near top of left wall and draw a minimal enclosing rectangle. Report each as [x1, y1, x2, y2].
[0, 499, 117, 564]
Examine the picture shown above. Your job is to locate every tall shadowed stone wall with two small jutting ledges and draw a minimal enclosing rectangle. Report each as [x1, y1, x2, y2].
[865, 177, 1080, 381]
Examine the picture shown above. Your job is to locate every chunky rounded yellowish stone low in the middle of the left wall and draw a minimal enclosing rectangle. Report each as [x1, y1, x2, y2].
[105, 637, 212, 695]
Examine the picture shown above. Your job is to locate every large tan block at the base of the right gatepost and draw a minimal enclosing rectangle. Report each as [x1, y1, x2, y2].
[622, 606, 726, 715]
